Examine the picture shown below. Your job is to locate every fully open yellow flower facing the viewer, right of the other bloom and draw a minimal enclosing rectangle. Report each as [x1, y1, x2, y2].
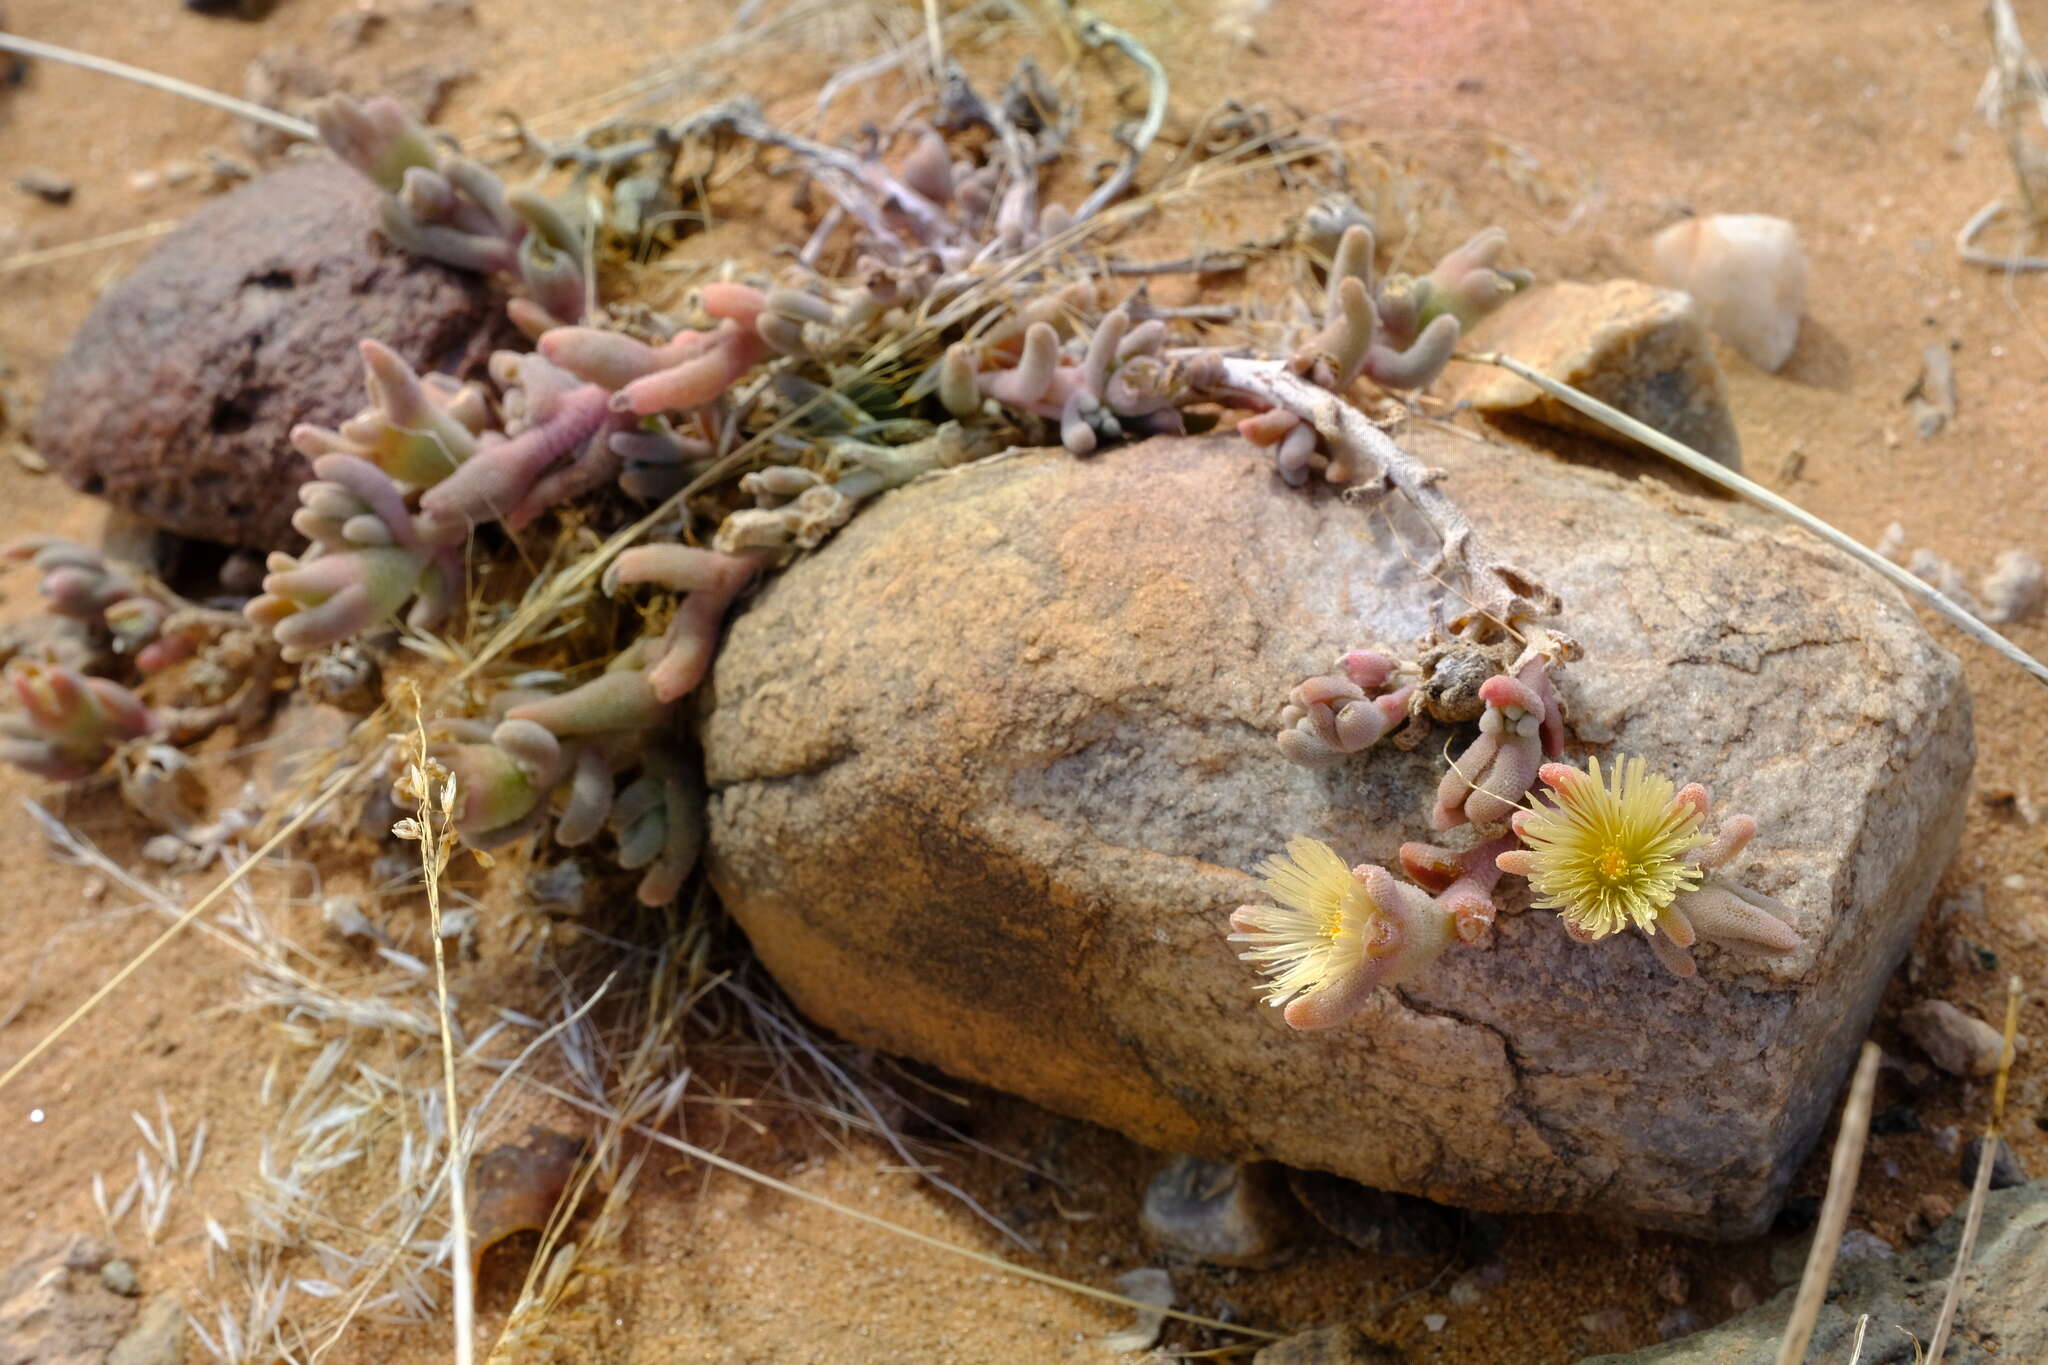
[1503, 755, 1704, 939]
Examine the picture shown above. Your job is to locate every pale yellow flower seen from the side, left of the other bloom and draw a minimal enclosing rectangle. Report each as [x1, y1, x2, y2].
[1231, 837, 1380, 1005]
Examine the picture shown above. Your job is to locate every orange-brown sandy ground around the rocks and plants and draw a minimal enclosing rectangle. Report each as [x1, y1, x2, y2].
[0, 0, 2048, 1363]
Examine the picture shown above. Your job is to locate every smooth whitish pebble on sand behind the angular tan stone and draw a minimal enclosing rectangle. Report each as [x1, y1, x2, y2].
[1651, 213, 1806, 370]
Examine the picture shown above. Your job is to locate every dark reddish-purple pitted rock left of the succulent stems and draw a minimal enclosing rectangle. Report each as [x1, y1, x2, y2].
[35, 160, 510, 551]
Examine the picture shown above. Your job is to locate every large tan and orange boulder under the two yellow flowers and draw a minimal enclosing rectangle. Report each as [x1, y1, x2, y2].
[705, 430, 1972, 1236]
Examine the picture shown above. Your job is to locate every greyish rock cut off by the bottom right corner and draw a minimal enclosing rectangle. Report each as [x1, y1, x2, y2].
[1581, 1181, 2048, 1365]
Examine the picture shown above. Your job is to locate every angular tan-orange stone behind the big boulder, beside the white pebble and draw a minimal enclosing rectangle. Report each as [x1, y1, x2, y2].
[1444, 280, 1743, 471]
